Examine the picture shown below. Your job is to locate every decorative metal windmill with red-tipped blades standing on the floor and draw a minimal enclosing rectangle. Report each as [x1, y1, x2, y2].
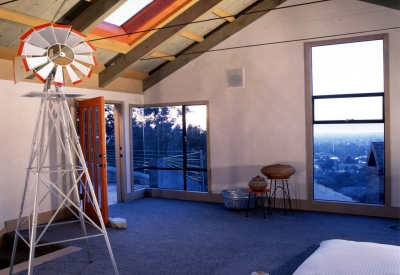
[10, 23, 118, 275]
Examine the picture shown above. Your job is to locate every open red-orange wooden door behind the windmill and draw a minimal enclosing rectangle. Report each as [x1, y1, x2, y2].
[79, 96, 108, 224]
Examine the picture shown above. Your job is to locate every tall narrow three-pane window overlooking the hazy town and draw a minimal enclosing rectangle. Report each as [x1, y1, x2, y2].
[306, 36, 385, 205]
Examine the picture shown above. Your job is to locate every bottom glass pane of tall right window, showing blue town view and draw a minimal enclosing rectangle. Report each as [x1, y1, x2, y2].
[314, 123, 385, 205]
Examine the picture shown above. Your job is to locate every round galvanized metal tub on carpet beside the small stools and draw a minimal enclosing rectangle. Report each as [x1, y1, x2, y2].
[221, 189, 254, 211]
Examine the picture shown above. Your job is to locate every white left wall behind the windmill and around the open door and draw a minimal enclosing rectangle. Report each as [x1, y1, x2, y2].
[0, 80, 143, 230]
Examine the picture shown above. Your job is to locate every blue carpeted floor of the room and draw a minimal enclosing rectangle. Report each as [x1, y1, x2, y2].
[3, 198, 400, 275]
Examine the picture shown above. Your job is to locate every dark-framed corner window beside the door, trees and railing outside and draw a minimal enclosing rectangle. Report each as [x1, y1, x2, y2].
[132, 105, 208, 192]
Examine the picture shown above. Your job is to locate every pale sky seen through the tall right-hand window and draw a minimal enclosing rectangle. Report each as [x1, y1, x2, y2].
[312, 40, 384, 133]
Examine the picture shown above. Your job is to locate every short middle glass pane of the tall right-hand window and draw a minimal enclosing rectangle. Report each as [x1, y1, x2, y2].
[314, 96, 383, 121]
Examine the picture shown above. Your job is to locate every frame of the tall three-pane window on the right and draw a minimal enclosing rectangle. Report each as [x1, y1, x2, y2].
[304, 33, 391, 210]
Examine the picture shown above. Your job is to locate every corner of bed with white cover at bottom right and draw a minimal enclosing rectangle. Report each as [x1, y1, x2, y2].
[293, 240, 400, 275]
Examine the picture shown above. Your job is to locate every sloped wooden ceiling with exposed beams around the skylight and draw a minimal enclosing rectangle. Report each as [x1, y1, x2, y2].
[0, 0, 400, 91]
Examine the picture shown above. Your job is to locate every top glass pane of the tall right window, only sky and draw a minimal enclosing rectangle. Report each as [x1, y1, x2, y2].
[311, 40, 384, 95]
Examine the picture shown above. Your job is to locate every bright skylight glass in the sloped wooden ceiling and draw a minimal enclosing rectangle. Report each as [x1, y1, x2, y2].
[104, 0, 153, 26]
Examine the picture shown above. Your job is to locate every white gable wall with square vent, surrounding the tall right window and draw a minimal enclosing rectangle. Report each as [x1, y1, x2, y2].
[144, 0, 400, 206]
